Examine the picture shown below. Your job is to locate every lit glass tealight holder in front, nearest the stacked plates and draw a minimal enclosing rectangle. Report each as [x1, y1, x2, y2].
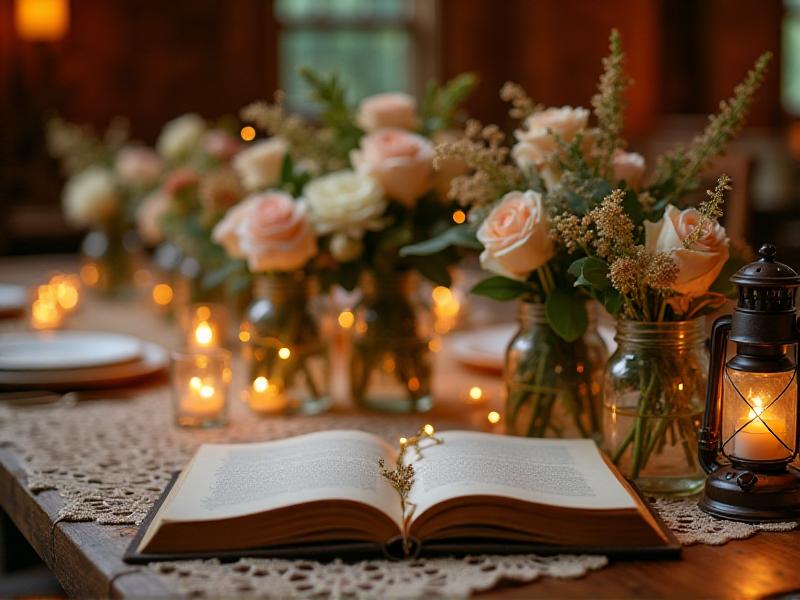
[170, 348, 232, 427]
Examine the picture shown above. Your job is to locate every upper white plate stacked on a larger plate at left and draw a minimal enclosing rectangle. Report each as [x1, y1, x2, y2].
[0, 331, 142, 371]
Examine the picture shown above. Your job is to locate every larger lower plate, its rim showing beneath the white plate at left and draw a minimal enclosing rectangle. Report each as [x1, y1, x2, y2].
[0, 342, 169, 390]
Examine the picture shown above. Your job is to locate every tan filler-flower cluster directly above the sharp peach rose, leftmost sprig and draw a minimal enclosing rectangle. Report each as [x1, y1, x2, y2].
[433, 120, 524, 206]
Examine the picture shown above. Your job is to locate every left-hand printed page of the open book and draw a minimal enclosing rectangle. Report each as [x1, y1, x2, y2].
[160, 431, 402, 524]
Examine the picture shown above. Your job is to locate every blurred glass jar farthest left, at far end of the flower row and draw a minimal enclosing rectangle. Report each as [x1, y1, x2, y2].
[81, 227, 139, 298]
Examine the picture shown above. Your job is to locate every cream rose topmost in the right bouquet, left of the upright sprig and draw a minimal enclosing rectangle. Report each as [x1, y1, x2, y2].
[511, 106, 589, 169]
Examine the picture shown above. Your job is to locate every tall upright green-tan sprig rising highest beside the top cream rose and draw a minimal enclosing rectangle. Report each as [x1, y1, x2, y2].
[592, 29, 631, 173]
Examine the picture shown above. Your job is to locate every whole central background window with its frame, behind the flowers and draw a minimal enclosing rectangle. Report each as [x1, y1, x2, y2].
[275, 0, 437, 110]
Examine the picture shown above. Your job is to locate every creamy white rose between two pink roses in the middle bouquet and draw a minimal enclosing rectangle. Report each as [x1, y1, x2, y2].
[303, 171, 387, 238]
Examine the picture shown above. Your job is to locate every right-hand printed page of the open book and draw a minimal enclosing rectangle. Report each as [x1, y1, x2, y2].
[406, 431, 637, 515]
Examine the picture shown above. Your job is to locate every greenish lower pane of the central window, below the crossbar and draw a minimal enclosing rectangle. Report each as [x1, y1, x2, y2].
[280, 29, 411, 111]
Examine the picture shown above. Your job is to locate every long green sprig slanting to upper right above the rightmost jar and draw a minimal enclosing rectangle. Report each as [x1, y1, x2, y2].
[653, 52, 772, 198]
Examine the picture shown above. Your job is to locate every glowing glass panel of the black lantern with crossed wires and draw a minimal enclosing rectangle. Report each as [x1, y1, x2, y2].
[722, 367, 797, 461]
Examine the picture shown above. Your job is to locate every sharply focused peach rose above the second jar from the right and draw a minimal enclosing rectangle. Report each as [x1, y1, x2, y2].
[478, 191, 554, 280]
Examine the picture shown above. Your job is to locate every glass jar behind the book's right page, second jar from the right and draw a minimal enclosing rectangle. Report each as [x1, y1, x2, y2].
[505, 302, 608, 440]
